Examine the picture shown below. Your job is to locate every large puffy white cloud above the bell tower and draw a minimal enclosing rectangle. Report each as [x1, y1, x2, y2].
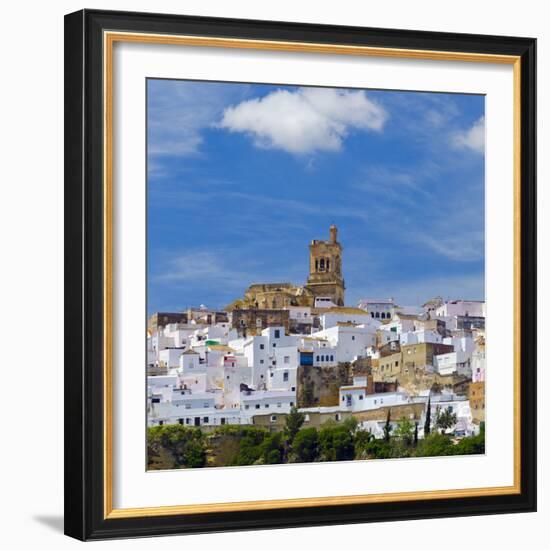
[218, 88, 387, 155]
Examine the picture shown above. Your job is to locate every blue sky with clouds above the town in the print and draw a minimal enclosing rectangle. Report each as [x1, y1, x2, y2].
[147, 79, 485, 313]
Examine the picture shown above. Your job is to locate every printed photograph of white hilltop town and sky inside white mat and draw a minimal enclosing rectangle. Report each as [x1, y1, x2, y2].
[146, 78, 488, 471]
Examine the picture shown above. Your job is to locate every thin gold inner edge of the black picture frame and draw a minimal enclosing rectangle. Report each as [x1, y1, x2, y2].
[103, 31, 521, 519]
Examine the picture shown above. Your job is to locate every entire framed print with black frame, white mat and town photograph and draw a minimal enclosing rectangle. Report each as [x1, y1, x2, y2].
[65, 10, 536, 540]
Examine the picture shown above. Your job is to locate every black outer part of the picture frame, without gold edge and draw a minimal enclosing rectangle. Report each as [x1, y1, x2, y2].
[65, 10, 537, 540]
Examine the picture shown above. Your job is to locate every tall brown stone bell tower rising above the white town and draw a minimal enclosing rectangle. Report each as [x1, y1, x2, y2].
[306, 225, 345, 306]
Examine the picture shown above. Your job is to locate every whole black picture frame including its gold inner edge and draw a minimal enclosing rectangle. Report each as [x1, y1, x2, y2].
[65, 10, 537, 540]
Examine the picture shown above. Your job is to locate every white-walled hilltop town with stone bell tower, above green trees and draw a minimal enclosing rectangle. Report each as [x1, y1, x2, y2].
[147, 226, 485, 468]
